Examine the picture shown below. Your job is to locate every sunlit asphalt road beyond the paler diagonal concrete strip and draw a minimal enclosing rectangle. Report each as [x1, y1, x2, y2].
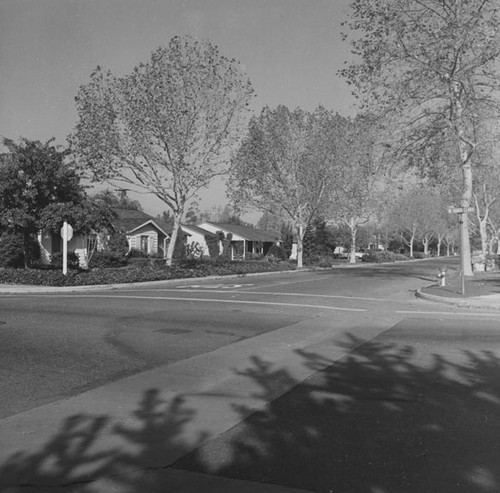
[0, 259, 492, 418]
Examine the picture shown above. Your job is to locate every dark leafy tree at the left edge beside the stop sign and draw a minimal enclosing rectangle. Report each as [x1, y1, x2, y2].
[0, 139, 112, 264]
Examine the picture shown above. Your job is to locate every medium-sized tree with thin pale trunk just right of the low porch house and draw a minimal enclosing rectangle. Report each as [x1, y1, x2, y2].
[229, 106, 344, 267]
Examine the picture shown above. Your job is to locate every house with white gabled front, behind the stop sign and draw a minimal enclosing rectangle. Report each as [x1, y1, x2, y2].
[38, 209, 170, 266]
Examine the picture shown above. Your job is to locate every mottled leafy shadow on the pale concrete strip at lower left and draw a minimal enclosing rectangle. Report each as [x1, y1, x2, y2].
[0, 389, 205, 493]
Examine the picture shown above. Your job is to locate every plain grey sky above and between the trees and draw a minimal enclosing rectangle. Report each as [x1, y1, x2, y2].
[0, 0, 355, 220]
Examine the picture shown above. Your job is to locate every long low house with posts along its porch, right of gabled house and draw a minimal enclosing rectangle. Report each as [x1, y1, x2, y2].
[196, 222, 279, 260]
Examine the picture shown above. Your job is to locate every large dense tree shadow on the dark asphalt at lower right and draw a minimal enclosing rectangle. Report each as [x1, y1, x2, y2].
[176, 330, 500, 493]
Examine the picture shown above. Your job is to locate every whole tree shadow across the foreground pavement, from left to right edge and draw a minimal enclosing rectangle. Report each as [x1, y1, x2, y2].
[0, 328, 500, 493]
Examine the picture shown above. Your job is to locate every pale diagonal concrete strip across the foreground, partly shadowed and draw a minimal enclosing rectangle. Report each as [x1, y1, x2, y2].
[0, 300, 394, 493]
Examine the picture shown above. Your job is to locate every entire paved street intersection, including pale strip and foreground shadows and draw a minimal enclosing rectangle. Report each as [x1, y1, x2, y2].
[0, 263, 500, 493]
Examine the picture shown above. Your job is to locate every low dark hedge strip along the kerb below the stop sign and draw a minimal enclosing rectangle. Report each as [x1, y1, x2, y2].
[0, 261, 295, 286]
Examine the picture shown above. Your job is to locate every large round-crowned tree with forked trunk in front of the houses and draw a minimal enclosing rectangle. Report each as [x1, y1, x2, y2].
[70, 37, 253, 265]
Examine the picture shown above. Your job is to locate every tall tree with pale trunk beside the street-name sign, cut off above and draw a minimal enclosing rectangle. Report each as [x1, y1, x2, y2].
[342, 0, 500, 275]
